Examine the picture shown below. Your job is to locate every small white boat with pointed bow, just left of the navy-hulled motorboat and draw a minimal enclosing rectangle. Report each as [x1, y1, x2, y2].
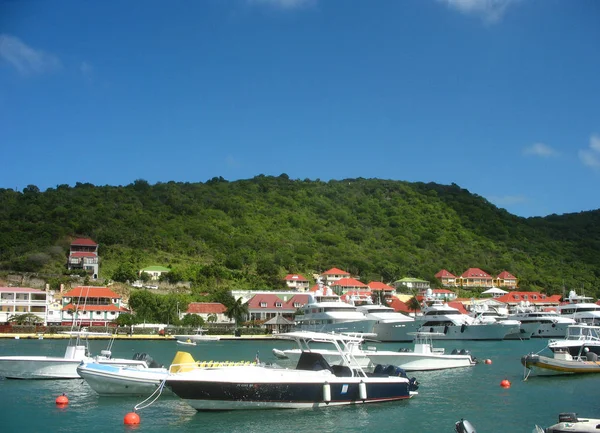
[77, 353, 169, 396]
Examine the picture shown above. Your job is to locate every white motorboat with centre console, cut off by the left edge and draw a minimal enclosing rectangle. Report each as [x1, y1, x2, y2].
[0, 333, 158, 379]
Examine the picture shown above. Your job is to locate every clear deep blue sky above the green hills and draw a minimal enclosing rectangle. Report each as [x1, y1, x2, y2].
[0, 0, 600, 217]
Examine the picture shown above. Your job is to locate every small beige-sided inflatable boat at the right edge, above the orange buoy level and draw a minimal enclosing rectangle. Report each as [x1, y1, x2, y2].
[521, 350, 600, 376]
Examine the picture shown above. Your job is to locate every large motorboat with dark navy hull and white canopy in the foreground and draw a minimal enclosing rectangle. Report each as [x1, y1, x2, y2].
[165, 331, 418, 411]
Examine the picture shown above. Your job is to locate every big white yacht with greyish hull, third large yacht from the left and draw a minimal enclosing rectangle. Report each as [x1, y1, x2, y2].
[416, 299, 519, 340]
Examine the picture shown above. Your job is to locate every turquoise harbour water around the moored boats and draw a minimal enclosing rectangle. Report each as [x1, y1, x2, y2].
[0, 340, 600, 433]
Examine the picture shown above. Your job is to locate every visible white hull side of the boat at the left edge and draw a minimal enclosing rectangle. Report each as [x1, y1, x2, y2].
[0, 356, 81, 379]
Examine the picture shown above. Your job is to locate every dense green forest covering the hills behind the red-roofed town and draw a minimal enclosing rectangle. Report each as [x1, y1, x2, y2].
[0, 174, 600, 297]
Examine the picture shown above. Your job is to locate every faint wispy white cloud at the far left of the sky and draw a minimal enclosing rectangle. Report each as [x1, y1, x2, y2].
[0, 34, 62, 75]
